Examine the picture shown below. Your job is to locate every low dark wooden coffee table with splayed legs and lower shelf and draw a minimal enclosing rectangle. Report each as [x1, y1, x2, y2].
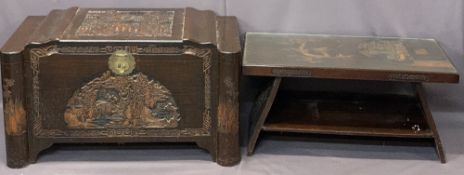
[242, 33, 459, 163]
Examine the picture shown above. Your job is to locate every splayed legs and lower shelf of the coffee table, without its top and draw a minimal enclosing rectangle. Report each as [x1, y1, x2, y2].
[248, 78, 446, 163]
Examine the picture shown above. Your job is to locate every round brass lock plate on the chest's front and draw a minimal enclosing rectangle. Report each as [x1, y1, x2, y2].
[108, 50, 135, 75]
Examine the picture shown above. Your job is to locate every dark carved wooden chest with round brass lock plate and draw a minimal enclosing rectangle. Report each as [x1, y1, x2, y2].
[1, 8, 240, 167]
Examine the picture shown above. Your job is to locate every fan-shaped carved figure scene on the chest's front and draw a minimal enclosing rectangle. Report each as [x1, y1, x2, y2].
[64, 71, 180, 128]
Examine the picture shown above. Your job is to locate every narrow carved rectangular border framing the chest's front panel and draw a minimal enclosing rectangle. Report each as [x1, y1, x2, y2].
[30, 45, 213, 137]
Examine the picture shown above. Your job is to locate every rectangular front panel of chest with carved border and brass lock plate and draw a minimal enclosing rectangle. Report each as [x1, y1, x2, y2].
[29, 45, 217, 137]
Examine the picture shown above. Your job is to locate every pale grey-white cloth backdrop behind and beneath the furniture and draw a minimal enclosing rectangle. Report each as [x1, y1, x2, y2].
[0, 0, 464, 175]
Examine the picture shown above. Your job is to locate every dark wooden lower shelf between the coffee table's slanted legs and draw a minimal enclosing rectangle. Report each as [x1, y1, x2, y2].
[263, 91, 433, 138]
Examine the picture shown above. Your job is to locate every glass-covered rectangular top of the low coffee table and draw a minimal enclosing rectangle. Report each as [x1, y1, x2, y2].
[242, 33, 459, 83]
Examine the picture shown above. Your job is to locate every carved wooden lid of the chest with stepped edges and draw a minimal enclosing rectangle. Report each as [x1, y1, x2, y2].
[1, 7, 241, 53]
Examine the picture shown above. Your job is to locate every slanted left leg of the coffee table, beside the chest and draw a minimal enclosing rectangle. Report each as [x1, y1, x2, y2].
[248, 77, 282, 155]
